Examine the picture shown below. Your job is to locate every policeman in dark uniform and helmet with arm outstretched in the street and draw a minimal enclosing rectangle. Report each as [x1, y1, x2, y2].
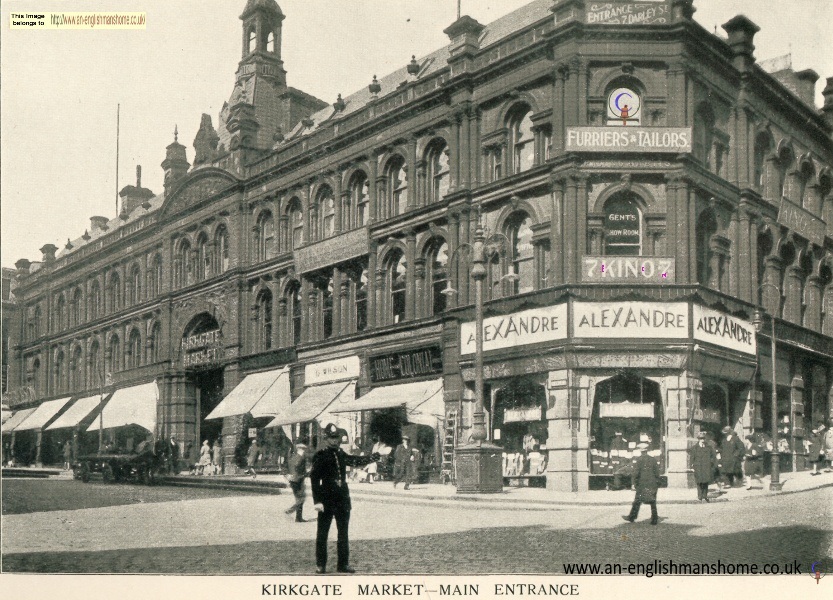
[310, 423, 379, 574]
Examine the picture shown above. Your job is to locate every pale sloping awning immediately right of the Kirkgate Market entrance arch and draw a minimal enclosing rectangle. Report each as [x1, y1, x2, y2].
[206, 367, 292, 419]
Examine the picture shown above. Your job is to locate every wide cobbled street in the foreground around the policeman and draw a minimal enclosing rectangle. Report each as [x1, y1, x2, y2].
[2, 480, 833, 574]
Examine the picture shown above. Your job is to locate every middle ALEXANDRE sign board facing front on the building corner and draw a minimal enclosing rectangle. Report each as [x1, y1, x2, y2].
[573, 302, 688, 339]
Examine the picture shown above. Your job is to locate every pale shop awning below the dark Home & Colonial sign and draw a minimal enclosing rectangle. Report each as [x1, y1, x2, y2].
[328, 379, 445, 427]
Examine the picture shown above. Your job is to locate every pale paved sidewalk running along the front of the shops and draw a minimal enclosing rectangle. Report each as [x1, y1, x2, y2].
[158, 471, 833, 510]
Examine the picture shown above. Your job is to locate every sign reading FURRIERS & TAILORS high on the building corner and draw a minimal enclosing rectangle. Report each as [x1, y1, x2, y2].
[567, 127, 692, 154]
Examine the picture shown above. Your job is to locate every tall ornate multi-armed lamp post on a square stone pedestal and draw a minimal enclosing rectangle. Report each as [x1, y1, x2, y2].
[443, 216, 516, 494]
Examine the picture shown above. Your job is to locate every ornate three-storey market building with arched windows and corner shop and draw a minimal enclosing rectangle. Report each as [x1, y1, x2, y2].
[1, 0, 833, 490]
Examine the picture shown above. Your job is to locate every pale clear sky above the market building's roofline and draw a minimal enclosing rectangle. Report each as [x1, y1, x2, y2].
[0, 0, 833, 267]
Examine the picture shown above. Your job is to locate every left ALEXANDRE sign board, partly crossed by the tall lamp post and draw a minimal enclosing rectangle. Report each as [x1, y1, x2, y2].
[460, 304, 567, 354]
